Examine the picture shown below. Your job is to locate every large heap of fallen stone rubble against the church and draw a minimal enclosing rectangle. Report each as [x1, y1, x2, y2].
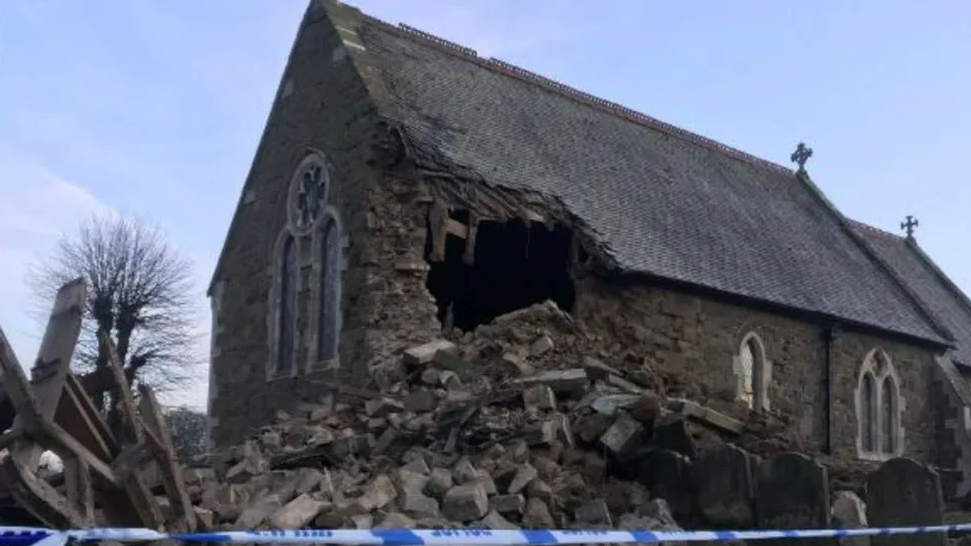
[187, 303, 776, 529]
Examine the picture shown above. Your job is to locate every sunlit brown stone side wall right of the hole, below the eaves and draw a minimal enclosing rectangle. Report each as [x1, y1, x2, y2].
[577, 278, 936, 462]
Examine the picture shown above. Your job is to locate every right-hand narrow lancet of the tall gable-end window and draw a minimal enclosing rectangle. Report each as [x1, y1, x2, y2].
[317, 215, 342, 362]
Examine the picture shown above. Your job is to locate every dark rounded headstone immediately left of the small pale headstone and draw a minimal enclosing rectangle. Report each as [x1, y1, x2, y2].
[755, 453, 833, 545]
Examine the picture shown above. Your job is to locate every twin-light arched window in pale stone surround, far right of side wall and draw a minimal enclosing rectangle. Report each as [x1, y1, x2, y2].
[856, 349, 903, 460]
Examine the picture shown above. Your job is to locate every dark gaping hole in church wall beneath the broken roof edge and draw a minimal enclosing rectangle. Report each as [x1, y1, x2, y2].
[425, 211, 576, 332]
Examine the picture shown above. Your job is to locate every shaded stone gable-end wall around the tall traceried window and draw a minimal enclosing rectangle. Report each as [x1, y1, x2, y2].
[210, 2, 388, 445]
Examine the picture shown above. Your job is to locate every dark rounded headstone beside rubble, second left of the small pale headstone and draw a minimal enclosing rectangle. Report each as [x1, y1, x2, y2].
[691, 444, 758, 529]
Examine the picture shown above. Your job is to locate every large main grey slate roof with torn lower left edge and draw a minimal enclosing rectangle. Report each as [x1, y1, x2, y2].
[348, 12, 946, 342]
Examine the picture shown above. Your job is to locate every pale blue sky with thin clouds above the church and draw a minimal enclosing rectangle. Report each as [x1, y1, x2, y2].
[0, 0, 971, 407]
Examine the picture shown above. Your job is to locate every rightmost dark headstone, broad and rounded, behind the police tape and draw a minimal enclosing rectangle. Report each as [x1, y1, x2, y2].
[866, 458, 947, 546]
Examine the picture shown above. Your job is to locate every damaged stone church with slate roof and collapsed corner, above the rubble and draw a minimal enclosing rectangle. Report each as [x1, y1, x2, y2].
[203, 0, 971, 489]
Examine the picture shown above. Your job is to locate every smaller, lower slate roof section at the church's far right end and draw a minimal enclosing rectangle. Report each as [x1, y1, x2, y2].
[851, 221, 971, 367]
